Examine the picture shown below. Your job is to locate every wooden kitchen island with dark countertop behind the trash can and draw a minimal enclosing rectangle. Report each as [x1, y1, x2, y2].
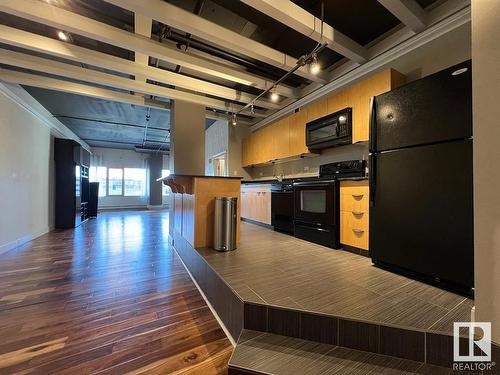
[158, 174, 241, 248]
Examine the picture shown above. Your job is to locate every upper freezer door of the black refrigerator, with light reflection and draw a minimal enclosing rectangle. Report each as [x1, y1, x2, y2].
[370, 61, 472, 152]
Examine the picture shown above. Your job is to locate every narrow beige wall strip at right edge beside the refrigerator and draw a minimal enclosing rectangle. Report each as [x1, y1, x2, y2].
[472, 0, 500, 346]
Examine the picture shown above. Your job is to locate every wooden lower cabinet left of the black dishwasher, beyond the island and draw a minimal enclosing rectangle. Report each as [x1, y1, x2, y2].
[241, 185, 271, 225]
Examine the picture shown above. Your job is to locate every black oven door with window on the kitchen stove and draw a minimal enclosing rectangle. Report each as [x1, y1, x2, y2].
[293, 180, 337, 225]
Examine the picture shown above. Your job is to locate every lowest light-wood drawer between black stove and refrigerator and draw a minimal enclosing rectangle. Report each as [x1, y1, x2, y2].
[340, 212, 368, 250]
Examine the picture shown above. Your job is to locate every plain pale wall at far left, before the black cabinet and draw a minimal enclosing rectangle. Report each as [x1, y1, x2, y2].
[0, 92, 54, 253]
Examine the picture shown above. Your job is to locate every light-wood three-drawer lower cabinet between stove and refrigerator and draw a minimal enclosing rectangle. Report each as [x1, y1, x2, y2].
[340, 180, 369, 250]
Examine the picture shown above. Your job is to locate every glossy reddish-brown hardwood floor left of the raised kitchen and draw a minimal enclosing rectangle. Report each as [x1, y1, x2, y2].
[0, 211, 233, 374]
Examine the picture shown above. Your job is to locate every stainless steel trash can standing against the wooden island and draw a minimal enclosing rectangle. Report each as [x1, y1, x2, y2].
[214, 197, 238, 251]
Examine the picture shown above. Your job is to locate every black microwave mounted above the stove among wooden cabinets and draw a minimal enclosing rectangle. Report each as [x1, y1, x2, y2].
[306, 107, 352, 150]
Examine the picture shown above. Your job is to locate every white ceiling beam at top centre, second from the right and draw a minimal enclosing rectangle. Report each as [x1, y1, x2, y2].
[242, 0, 367, 63]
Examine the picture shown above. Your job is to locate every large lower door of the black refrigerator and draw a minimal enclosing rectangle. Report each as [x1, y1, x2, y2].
[370, 140, 474, 288]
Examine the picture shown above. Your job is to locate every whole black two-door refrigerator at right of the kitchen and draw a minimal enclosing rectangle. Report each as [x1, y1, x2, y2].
[369, 61, 474, 295]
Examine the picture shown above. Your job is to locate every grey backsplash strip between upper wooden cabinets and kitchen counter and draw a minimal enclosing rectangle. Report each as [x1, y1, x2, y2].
[245, 142, 368, 180]
